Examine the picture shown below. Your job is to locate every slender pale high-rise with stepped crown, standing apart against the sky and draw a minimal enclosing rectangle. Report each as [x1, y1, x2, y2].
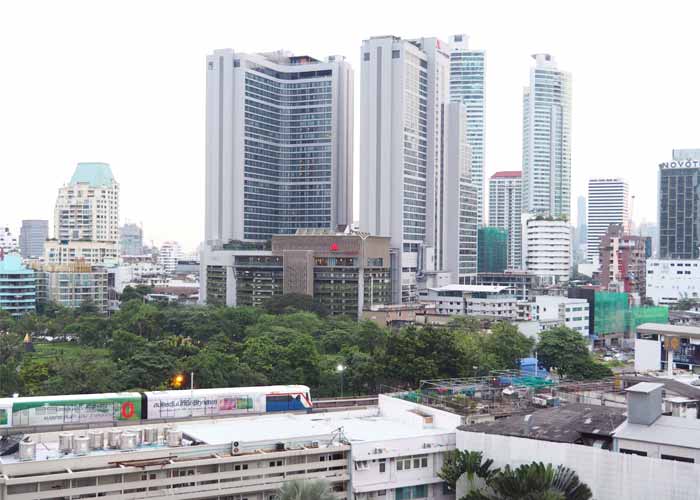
[523, 54, 571, 218]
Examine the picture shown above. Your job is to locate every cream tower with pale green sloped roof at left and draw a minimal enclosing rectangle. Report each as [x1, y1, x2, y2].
[54, 163, 119, 245]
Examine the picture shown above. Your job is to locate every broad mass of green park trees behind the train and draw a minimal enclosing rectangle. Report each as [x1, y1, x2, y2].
[0, 290, 600, 396]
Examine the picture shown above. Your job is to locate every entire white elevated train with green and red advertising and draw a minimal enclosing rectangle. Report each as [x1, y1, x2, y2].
[0, 385, 313, 428]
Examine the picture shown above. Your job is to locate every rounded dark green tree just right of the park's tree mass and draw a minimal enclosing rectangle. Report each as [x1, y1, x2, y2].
[537, 326, 612, 379]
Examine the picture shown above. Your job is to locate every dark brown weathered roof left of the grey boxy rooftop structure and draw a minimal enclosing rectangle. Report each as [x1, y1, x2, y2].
[459, 403, 625, 443]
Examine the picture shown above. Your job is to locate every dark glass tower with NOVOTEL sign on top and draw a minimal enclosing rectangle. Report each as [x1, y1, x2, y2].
[658, 149, 700, 259]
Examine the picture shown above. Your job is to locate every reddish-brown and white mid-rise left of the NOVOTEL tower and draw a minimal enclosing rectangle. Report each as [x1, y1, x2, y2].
[599, 224, 651, 302]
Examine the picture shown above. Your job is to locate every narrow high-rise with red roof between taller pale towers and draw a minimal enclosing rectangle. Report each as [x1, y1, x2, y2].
[489, 170, 523, 269]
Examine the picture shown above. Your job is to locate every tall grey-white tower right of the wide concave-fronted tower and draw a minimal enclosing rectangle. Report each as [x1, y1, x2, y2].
[360, 36, 458, 303]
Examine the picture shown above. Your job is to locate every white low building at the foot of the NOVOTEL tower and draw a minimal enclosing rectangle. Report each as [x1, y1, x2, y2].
[646, 259, 700, 306]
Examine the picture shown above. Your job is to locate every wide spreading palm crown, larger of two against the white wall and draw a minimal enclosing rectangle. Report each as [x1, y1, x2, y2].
[464, 462, 593, 500]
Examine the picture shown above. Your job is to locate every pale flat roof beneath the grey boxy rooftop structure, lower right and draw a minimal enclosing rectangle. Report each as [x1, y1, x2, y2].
[615, 415, 700, 449]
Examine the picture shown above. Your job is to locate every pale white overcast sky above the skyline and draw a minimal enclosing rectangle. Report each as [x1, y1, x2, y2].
[0, 0, 700, 250]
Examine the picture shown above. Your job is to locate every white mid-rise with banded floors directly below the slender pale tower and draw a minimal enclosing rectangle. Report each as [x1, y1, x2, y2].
[522, 214, 571, 285]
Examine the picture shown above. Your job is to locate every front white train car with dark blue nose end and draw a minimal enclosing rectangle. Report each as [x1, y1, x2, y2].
[142, 385, 313, 420]
